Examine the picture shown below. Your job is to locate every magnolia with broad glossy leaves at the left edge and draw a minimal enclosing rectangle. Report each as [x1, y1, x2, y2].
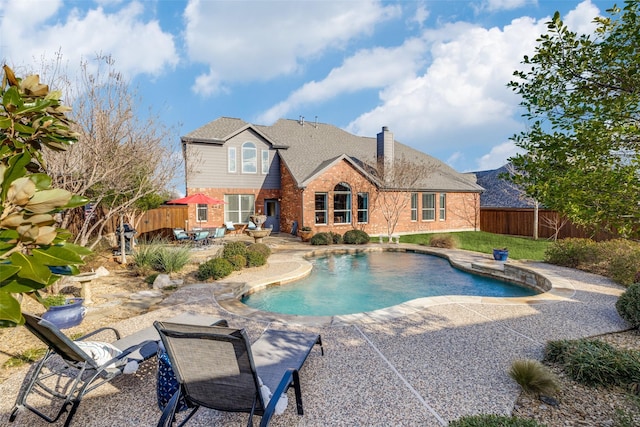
[0, 65, 90, 326]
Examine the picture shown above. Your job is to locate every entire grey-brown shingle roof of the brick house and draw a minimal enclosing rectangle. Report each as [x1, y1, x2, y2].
[182, 117, 483, 192]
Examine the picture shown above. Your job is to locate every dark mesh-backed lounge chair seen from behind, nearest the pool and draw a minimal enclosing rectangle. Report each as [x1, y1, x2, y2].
[154, 322, 324, 427]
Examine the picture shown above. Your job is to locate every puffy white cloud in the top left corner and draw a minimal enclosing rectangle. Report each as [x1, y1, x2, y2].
[0, 0, 178, 78]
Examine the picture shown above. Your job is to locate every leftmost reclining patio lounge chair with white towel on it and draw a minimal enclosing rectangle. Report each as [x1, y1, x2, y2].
[9, 313, 158, 427]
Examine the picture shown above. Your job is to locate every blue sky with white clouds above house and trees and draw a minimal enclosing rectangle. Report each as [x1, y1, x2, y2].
[0, 0, 608, 189]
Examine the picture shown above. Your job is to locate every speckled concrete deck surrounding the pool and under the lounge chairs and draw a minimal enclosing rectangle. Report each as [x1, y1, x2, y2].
[0, 239, 628, 426]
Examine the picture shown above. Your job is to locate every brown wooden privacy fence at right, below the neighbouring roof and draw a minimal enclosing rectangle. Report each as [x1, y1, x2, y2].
[480, 208, 614, 240]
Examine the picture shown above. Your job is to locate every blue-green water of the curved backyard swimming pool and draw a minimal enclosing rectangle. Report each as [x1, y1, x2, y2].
[242, 252, 538, 316]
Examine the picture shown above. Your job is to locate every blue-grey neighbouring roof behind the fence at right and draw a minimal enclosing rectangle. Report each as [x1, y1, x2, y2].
[474, 165, 534, 208]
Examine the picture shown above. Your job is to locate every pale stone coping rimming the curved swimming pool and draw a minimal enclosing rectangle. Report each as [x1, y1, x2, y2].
[214, 243, 576, 326]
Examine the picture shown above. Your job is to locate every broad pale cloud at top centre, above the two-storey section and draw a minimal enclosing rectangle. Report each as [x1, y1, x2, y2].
[184, 0, 400, 95]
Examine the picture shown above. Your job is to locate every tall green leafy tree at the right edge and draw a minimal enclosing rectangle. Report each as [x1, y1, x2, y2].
[509, 0, 640, 235]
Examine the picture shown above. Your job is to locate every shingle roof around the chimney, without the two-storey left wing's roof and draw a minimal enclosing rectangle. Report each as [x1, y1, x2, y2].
[254, 119, 483, 192]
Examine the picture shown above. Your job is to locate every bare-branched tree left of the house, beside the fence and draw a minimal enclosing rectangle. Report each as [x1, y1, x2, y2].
[46, 56, 182, 247]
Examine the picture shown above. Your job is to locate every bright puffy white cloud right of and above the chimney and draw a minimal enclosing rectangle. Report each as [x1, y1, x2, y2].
[348, 18, 544, 146]
